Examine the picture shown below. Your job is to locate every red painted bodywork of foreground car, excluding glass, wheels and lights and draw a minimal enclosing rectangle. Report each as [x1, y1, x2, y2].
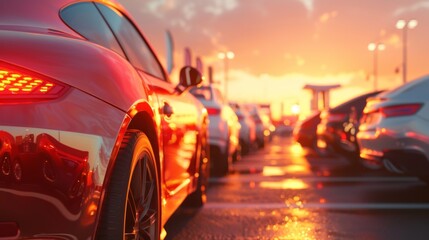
[0, 0, 206, 239]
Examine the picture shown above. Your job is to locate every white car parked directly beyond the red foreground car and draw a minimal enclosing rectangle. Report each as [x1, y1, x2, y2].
[190, 85, 241, 176]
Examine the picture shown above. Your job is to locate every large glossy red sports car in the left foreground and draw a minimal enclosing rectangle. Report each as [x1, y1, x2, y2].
[0, 0, 209, 239]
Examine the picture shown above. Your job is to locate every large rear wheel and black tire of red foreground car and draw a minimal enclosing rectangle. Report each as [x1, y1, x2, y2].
[96, 130, 161, 240]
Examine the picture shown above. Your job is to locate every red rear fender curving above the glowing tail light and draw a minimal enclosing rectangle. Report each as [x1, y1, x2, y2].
[0, 30, 147, 112]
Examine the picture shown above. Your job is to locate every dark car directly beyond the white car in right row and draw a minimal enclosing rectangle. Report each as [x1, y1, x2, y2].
[317, 91, 381, 164]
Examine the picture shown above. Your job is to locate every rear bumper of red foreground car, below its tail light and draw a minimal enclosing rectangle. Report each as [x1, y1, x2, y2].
[0, 90, 126, 239]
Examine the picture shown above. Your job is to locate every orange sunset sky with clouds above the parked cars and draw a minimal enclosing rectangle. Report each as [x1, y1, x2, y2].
[118, 0, 429, 119]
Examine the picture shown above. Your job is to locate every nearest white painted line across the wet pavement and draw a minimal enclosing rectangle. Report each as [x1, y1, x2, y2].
[204, 202, 429, 211]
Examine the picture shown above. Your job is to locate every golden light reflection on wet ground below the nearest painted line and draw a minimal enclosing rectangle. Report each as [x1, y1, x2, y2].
[167, 208, 330, 240]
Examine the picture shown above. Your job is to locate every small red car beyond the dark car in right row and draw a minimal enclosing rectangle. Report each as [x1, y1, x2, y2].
[292, 111, 320, 150]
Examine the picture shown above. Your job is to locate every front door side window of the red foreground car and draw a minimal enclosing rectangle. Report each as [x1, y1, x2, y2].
[96, 3, 166, 80]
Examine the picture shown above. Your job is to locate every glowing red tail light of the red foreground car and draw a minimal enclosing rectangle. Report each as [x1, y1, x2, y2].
[0, 62, 66, 102]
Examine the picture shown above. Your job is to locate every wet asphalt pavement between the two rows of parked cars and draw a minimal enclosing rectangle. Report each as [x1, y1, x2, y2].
[166, 136, 429, 240]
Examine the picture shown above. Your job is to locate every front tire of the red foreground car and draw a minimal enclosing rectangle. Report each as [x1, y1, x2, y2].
[184, 122, 210, 208]
